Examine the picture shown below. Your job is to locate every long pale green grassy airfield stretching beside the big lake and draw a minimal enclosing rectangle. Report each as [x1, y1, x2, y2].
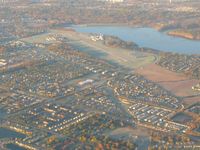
[21, 29, 157, 69]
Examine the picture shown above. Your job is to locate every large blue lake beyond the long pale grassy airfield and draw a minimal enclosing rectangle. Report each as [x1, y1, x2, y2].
[70, 25, 200, 54]
